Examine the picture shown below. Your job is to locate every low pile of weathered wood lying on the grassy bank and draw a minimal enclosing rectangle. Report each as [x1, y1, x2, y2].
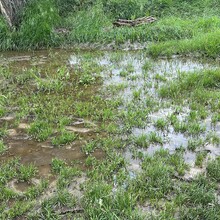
[113, 16, 157, 27]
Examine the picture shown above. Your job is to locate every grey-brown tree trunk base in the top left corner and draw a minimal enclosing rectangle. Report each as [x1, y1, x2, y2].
[0, 0, 27, 26]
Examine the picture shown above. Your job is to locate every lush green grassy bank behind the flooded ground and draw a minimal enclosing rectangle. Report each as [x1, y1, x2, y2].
[0, 0, 220, 57]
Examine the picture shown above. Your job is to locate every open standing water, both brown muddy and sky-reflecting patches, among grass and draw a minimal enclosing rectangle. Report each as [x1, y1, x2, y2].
[0, 50, 220, 180]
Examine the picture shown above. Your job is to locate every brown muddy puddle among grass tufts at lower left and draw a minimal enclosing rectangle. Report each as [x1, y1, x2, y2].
[0, 117, 104, 176]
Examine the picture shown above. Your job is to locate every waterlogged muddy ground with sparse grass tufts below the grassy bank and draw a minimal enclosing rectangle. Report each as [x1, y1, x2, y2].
[0, 50, 220, 219]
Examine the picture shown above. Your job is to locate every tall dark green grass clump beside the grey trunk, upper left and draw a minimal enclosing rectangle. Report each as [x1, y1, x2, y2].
[0, 0, 59, 50]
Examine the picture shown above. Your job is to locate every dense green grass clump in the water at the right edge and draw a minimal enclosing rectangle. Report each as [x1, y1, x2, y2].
[159, 69, 220, 109]
